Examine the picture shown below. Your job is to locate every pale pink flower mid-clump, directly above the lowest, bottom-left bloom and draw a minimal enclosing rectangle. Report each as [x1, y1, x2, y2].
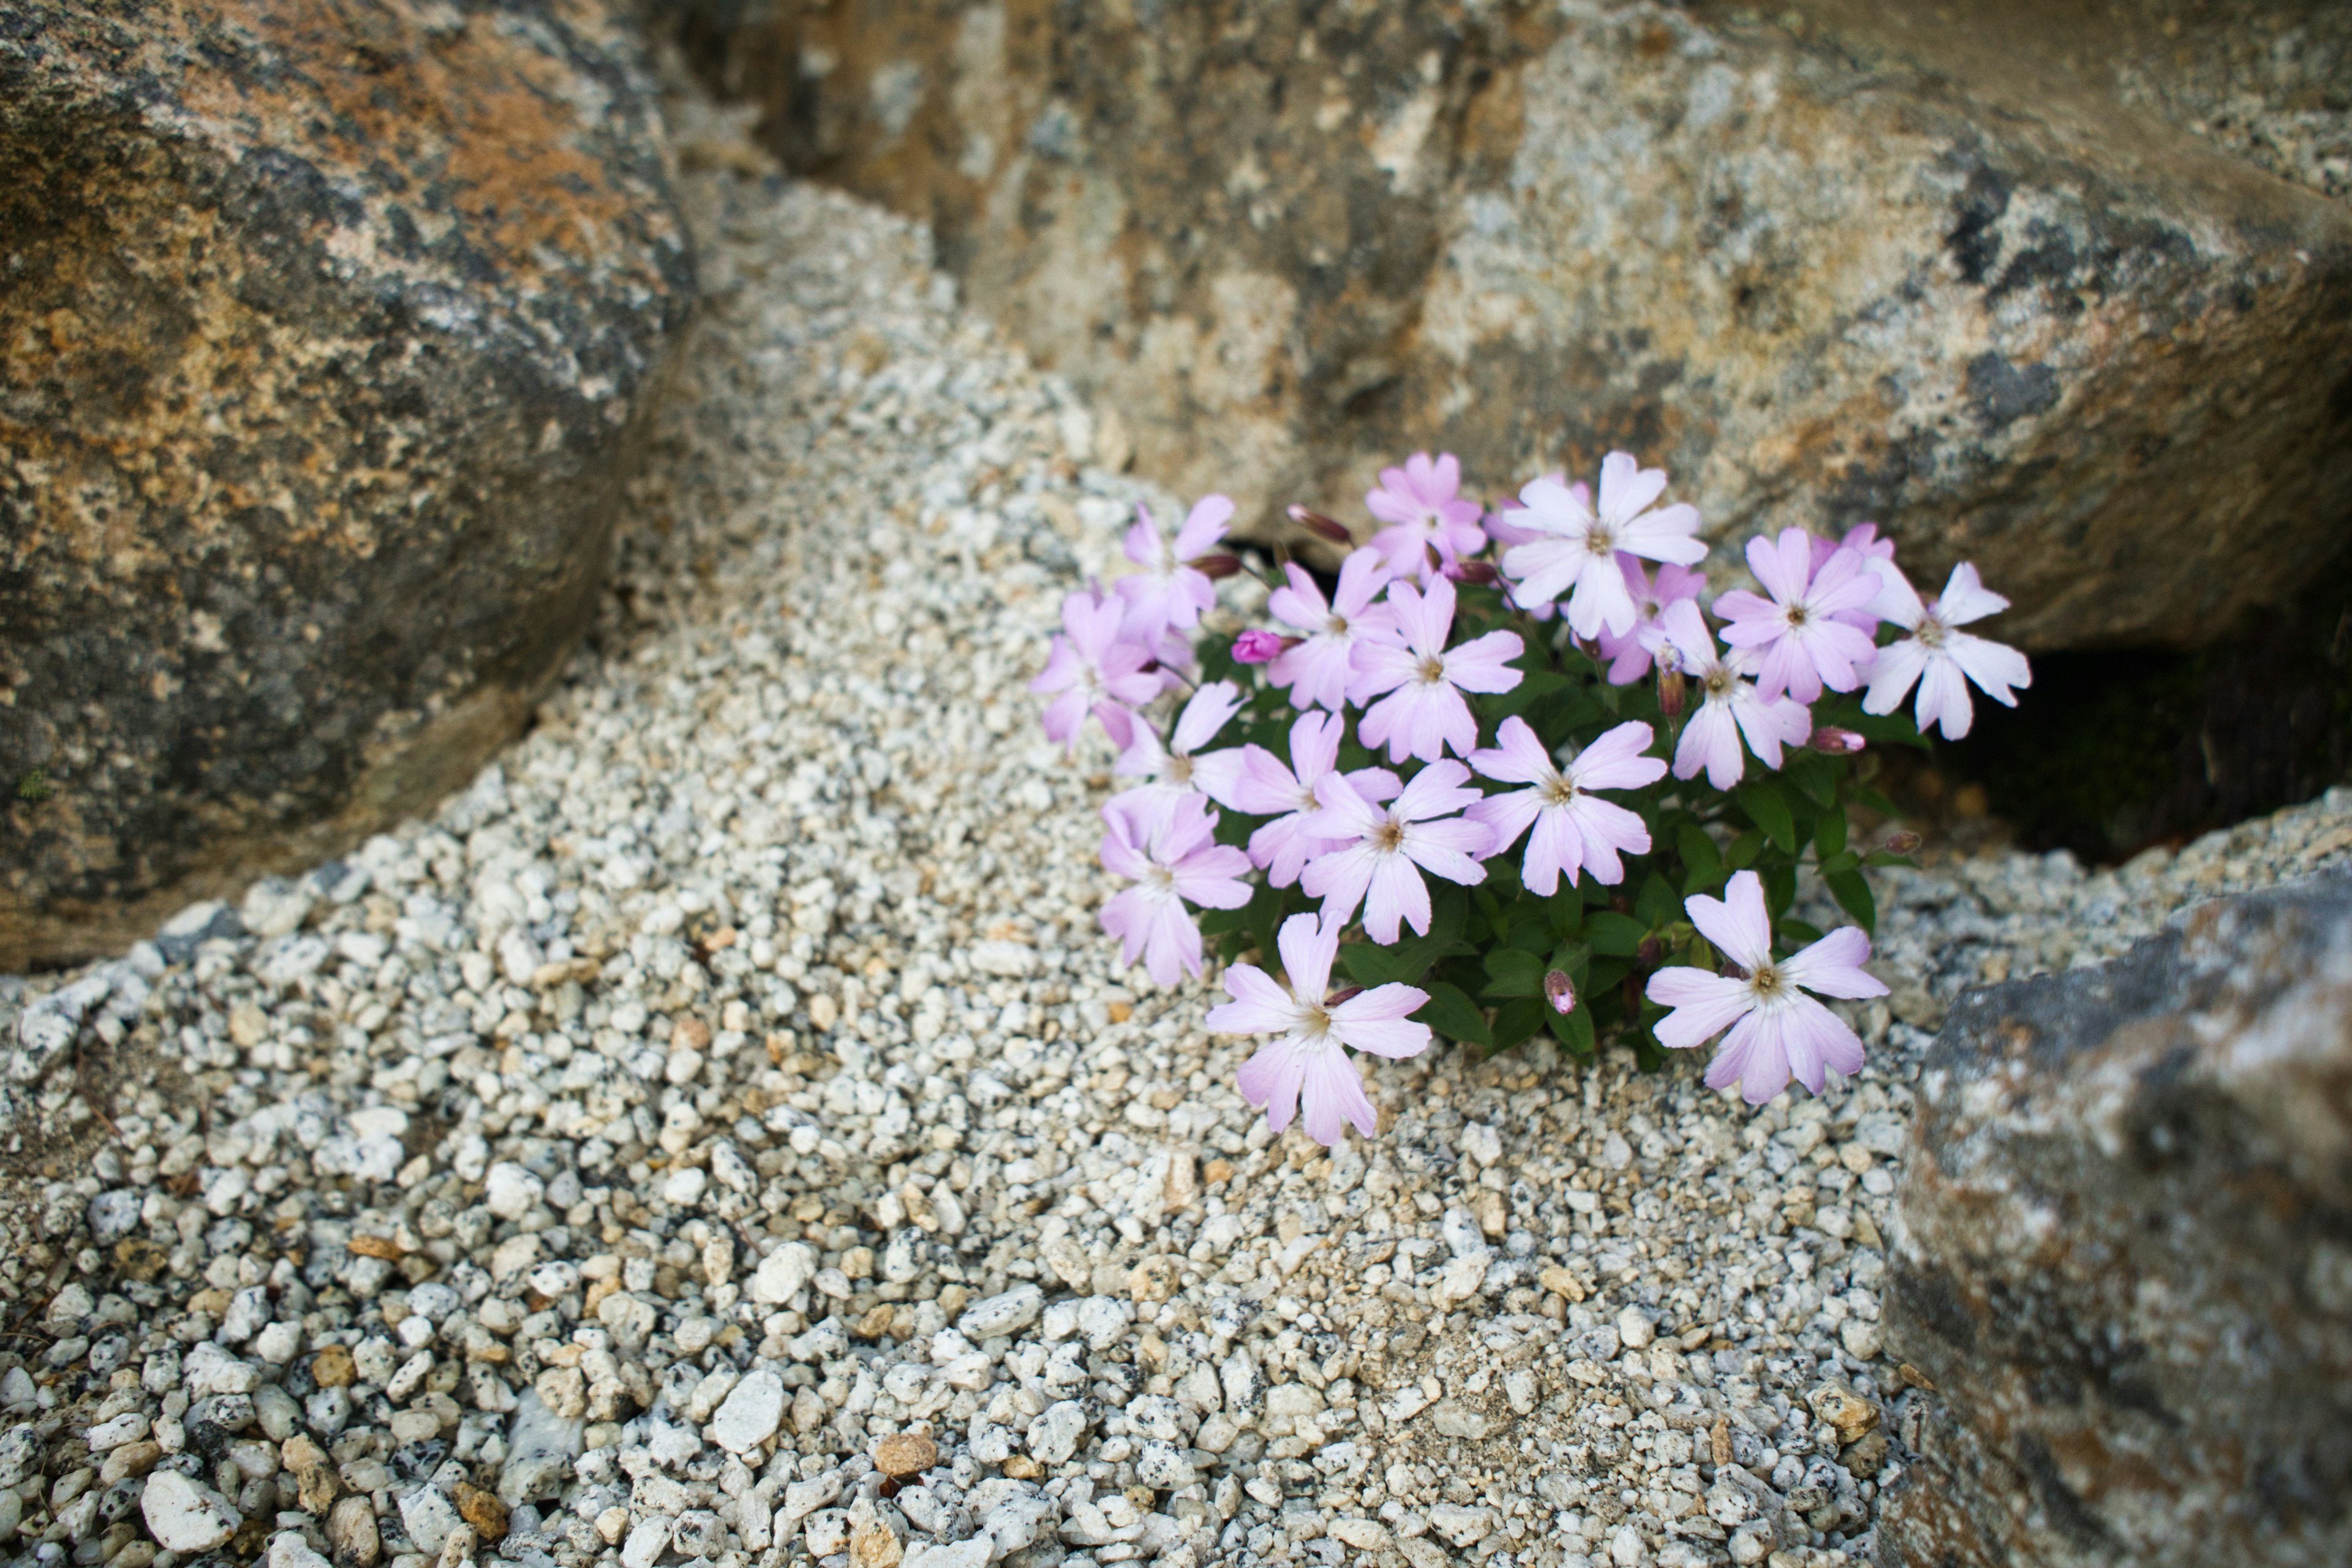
[1298, 757, 1493, 948]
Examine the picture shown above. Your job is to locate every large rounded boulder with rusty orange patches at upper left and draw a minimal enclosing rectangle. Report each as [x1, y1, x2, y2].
[0, 0, 694, 968]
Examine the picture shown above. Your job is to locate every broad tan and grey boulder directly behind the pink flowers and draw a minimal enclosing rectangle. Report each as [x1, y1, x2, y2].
[682, 0, 2352, 649]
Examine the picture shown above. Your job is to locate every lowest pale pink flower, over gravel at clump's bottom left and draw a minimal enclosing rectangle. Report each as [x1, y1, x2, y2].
[1209, 914, 1430, 1147]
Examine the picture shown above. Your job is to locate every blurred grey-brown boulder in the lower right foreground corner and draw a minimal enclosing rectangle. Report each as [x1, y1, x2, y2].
[1879, 872, 2352, 1568]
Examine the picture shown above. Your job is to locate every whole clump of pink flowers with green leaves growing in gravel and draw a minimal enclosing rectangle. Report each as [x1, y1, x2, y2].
[1035, 451, 2032, 1142]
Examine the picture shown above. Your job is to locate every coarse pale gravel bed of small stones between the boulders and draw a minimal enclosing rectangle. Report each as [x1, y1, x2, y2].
[0, 104, 2352, 1568]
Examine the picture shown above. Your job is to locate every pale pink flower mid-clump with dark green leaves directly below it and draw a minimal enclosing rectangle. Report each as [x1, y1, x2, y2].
[1465, 717, 1665, 895]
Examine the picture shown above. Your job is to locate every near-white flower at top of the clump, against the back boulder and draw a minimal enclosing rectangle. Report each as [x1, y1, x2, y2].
[1503, 451, 1708, 637]
